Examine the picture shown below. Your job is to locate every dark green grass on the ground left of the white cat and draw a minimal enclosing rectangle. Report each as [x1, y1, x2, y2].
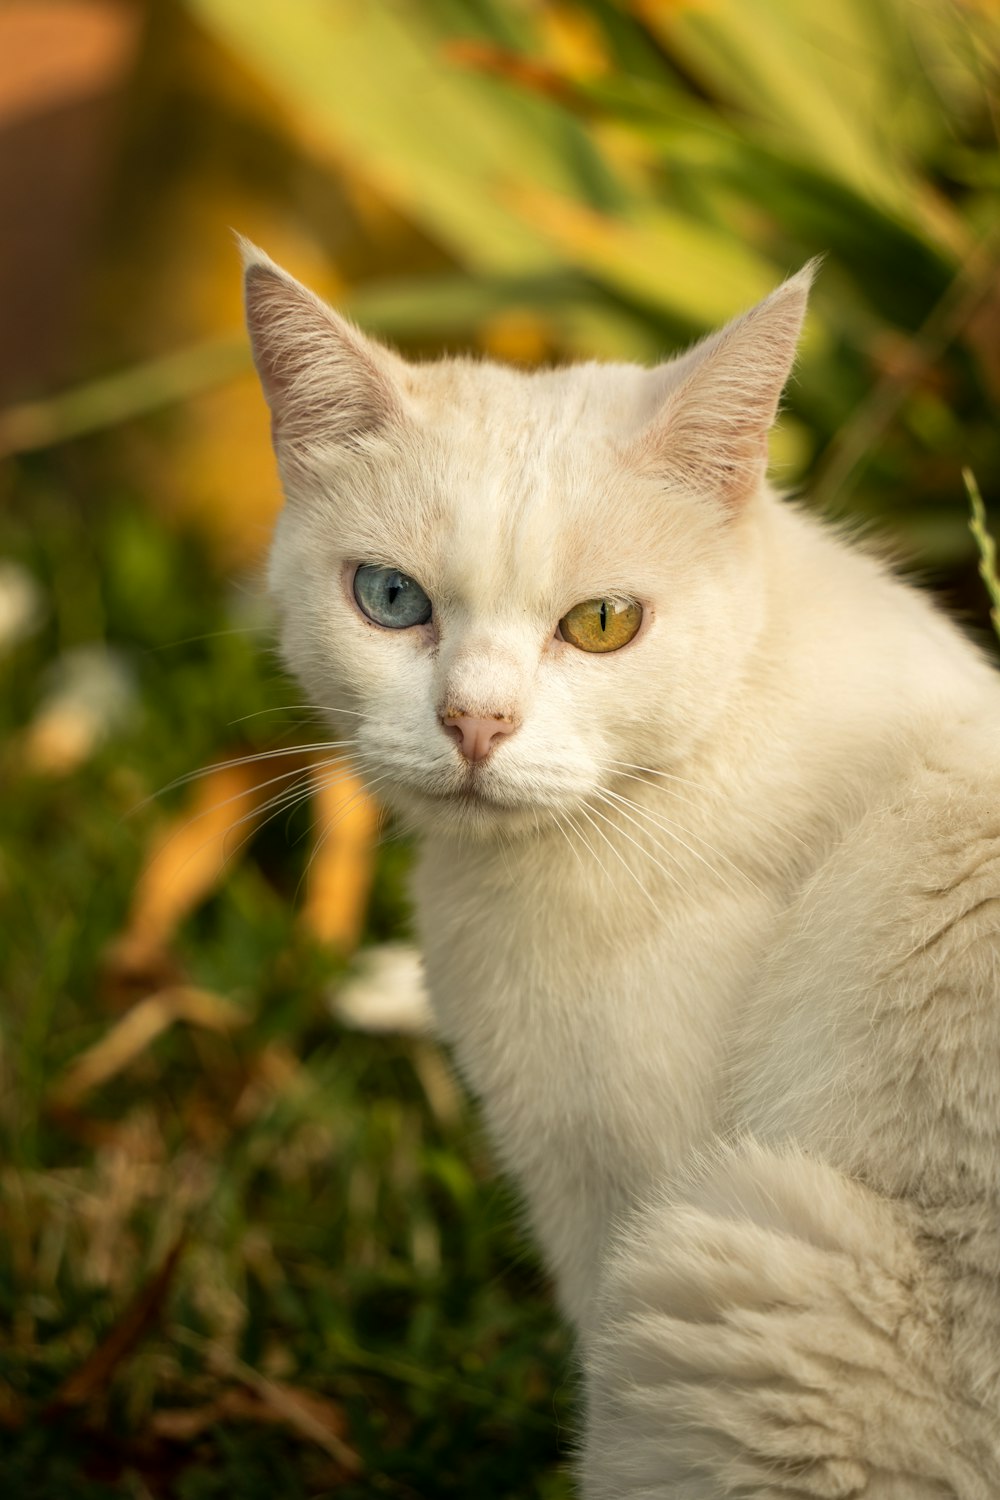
[0, 461, 574, 1500]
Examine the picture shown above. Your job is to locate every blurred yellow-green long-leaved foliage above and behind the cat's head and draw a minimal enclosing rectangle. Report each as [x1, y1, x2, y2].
[0, 0, 1000, 572]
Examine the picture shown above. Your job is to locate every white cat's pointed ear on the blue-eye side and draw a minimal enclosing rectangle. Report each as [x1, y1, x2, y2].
[238, 237, 402, 450]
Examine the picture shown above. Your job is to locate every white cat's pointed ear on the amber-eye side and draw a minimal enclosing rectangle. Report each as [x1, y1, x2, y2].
[636, 261, 819, 512]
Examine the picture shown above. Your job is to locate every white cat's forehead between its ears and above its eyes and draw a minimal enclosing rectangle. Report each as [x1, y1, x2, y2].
[386, 362, 671, 608]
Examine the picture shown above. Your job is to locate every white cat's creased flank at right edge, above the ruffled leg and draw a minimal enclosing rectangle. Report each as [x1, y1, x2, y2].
[733, 699, 1000, 1158]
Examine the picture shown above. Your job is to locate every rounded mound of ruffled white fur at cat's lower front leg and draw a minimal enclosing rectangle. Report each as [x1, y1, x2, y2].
[582, 1143, 1000, 1500]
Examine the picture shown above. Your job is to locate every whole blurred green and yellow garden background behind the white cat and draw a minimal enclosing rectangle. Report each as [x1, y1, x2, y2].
[0, 0, 1000, 1500]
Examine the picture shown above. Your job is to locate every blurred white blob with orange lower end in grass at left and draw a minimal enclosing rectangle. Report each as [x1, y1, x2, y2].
[24, 645, 136, 776]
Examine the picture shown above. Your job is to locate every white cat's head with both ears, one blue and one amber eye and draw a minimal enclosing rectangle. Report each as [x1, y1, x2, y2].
[244, 246, 811, 834]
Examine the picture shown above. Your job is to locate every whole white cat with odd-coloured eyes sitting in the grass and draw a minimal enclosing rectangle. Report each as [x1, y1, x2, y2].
[246, 246, 1000, 1500]
